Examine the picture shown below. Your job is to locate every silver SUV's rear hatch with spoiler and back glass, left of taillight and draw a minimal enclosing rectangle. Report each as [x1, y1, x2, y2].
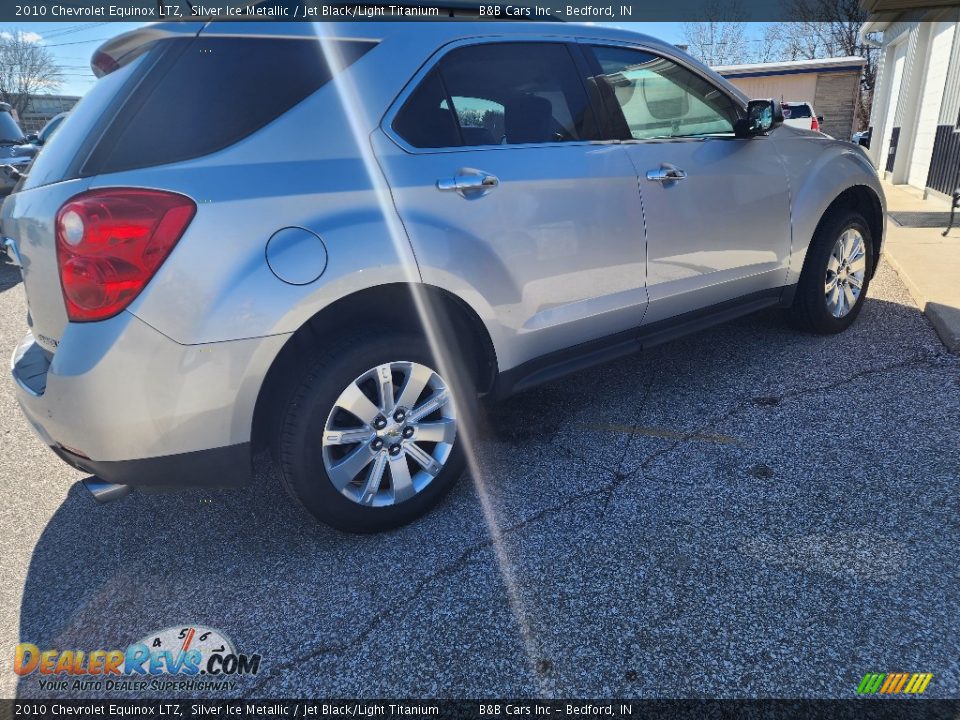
[0, 23, 203, 353]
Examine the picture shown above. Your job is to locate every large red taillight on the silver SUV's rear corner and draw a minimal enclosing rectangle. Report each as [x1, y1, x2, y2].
[56, 188, 197, 322]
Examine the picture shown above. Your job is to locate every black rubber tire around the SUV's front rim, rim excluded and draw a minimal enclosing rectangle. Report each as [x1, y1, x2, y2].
[790, 208, 873, 335]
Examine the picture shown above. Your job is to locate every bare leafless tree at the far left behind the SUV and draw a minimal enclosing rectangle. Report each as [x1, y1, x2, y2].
[0, 31, 61, 119]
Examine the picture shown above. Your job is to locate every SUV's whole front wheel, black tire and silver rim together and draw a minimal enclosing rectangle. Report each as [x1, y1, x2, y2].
[791, 209, 873, 334]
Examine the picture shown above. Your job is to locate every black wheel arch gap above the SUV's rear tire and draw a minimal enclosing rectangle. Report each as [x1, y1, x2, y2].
[251, 283, 499, 449]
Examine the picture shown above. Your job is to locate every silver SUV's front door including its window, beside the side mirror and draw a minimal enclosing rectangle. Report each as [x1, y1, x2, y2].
[582, 43, 791, 324]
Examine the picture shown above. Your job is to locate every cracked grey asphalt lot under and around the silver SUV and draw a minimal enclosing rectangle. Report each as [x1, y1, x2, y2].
[0, 258, 960, 698]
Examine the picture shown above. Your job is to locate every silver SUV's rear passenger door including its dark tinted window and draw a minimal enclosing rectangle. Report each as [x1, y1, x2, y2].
[373, 38, 647, 370]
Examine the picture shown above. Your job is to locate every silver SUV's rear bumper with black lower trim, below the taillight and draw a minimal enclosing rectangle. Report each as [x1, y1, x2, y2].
[11, 313, 286, 487]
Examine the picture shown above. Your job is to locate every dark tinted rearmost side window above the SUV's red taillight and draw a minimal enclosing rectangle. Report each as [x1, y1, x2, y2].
[81, 37, 374, 175]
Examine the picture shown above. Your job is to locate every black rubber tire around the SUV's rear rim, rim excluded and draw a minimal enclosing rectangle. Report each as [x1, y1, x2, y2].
[273, 328, 476, 533]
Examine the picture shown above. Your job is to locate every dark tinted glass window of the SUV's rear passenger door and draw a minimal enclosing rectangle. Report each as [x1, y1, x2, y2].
[393, 43, 598, 148]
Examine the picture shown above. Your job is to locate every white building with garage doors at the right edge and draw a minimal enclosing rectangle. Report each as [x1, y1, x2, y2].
[860, 11, 960, 197]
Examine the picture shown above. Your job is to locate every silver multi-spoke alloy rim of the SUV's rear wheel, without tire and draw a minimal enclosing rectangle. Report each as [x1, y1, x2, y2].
[323, 362, 457, 507]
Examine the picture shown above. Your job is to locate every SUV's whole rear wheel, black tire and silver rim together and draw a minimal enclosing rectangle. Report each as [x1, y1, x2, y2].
[276, 332, 472, 532]
